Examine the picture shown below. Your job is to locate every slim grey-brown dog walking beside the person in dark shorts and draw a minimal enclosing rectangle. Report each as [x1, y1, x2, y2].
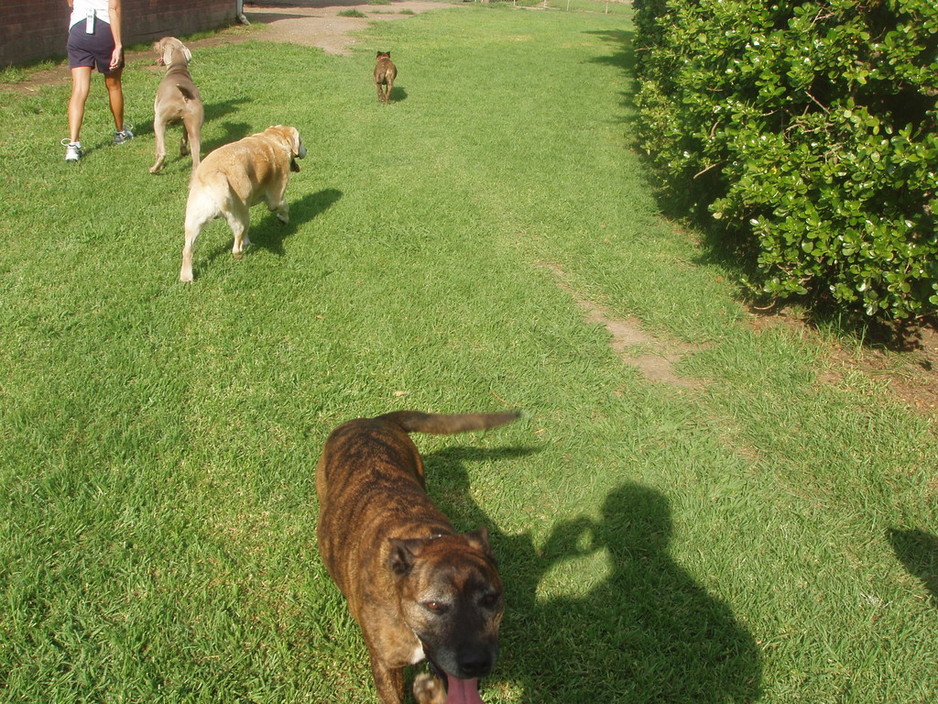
[150, 37, 205, 174]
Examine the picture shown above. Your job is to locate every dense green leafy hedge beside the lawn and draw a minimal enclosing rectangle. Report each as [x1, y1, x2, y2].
[635, 0, 938, 320]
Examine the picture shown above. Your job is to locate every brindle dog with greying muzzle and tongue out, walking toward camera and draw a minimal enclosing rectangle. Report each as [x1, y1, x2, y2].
[316, 411, 518, 704]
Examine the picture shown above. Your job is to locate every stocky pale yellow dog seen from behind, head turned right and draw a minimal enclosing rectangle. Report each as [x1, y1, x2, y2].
[179, 125, 306, 282]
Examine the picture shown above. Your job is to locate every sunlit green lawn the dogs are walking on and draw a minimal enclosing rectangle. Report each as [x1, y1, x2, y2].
[0, 4, 938, 704]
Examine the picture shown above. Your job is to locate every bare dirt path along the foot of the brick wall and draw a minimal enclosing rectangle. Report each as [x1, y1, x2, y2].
[0, 0, 462, 93]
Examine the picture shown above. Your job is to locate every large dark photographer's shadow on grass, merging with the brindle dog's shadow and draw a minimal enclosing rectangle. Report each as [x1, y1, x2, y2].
[425, 448, 762, 704]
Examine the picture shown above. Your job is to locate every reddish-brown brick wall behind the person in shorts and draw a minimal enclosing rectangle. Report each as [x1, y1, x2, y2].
[0, 0, 237, 67]
